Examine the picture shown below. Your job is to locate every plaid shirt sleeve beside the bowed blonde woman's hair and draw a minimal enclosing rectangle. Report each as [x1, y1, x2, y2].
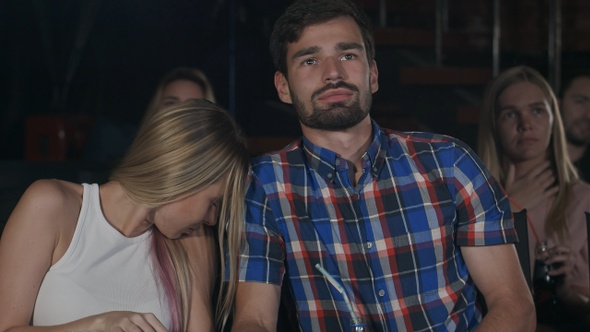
[239, 171, 285, 285]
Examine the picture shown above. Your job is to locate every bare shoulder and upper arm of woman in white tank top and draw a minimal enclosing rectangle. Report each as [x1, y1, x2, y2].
[0, 180, 72, 331]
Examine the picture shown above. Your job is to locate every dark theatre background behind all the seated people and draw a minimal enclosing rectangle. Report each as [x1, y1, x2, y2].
[0, 0, 590, 228]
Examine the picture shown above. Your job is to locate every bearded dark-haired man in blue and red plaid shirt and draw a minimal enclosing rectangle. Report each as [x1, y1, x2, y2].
[233, 0, 535, 331]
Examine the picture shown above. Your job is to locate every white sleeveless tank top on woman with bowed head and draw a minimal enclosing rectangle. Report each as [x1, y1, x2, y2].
[33, 184, 170, 329]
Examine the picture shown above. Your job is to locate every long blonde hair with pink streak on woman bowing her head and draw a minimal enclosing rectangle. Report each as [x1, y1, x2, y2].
[110, 99, 249, 330]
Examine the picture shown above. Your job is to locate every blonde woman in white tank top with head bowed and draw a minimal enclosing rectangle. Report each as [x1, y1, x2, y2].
[0, 100, 248, 331]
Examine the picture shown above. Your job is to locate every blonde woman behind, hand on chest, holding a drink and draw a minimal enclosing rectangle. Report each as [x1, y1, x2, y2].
[478, 66, 590, 322]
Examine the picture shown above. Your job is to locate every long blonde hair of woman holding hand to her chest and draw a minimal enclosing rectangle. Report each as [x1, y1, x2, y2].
[478, 66, 578, 237]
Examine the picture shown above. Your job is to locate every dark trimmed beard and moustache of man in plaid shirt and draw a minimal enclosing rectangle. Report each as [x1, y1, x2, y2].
[291, 81, 371, 131]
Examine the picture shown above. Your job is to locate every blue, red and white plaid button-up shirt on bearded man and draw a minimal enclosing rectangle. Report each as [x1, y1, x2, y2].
[240, 122, 516, 331]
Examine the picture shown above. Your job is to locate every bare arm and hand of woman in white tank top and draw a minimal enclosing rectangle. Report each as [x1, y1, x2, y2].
[0, 180, 166, 332]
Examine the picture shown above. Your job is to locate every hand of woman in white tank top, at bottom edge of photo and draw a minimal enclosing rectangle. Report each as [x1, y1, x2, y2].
[95, 311, 168, 332]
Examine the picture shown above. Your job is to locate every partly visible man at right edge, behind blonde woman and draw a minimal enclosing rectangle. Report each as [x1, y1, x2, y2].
[560, 72, 590, 182]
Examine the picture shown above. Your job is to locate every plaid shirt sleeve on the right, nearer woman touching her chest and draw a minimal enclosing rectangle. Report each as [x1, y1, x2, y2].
[453, 144, 518, 246]
